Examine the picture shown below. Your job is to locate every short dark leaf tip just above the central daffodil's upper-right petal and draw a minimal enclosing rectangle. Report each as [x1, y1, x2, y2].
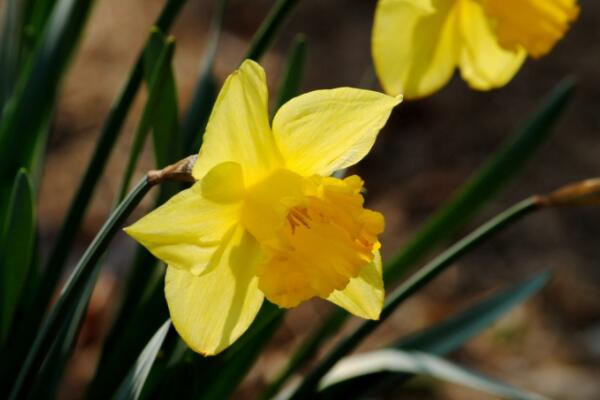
[275, 34, 306, 110]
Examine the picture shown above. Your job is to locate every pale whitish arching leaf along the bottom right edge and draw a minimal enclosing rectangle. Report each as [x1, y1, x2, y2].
[319, 349, 545, 400]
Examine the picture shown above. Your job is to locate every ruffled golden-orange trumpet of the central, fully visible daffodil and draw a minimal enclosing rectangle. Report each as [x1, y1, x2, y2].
[242, 170, 384, 307]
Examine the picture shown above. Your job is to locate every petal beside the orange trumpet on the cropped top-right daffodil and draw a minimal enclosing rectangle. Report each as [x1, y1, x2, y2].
[459, 0, 527, 90]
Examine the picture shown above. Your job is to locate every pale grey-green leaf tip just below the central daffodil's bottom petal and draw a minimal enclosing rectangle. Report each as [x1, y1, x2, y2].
[114, 320, 171, 400]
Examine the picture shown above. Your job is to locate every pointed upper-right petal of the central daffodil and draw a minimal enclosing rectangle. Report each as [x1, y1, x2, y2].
[273, 88, 401, 176]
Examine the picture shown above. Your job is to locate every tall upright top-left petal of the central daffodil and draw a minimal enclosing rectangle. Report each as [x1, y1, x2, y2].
[193, 60, 280, 184]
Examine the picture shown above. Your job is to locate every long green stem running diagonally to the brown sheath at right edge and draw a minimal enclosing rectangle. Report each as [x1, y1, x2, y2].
[289, 197, 540, 400]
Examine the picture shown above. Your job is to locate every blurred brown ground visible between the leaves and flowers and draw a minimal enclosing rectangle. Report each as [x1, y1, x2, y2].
[39, 0, 600, 399]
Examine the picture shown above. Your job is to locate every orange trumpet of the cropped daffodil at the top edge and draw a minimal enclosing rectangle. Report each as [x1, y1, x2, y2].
[479, 0, 579, 58]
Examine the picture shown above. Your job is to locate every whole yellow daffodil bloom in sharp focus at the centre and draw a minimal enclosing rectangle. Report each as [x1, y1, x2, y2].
[126, 61, 400, 355]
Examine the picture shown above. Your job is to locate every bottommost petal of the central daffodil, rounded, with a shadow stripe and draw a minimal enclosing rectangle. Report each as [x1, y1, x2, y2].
[165, 227, 264, 355]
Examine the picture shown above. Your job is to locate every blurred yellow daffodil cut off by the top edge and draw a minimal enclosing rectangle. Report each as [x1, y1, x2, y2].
[372, 0, 579, 98]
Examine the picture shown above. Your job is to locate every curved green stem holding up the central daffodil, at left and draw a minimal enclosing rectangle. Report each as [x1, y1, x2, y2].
[10, 178, 152, 400]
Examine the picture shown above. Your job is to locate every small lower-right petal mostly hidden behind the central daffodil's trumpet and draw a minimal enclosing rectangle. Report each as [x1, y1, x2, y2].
[327, 251, 384, 319]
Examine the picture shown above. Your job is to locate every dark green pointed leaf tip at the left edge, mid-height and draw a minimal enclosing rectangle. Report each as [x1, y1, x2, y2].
[0, 170, 36, 348]
